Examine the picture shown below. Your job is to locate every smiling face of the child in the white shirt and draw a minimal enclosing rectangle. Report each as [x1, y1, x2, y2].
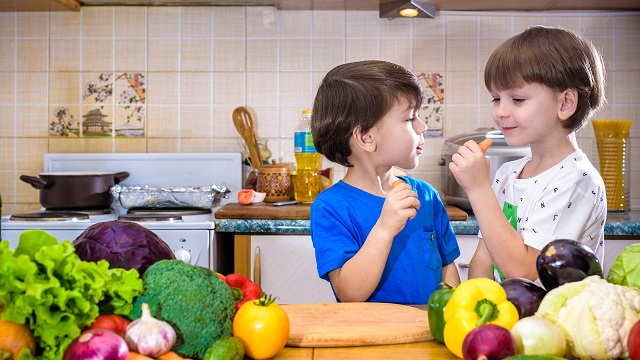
[490, 83, 563, 146]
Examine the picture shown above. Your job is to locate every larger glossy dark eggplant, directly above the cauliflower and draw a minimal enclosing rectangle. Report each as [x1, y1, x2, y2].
[536, 239, 602, 291]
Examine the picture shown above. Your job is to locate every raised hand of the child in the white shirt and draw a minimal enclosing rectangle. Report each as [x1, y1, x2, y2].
[449, 140, 491, 193]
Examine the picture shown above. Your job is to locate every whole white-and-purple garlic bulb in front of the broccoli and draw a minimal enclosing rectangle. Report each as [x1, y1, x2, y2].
[124, 304, 176, 357]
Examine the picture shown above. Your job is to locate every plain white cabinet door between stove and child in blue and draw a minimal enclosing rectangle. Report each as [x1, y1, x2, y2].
[251, 235, 336, 304]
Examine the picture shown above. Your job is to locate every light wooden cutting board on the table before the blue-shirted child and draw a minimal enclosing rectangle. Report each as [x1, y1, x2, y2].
[280, 303, 433, 347]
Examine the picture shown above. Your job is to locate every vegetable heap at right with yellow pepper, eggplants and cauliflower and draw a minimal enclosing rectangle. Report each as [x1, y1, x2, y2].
[428, 240, 640, 359]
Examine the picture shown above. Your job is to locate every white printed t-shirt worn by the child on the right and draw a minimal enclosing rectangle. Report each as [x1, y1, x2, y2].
[479, 150, 607, 261]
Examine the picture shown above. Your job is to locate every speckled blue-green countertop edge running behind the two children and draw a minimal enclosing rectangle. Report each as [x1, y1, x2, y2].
[215, 211, 640, 236]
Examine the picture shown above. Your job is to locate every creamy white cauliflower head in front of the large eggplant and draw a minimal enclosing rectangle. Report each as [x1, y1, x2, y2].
[537, 276, 640, 359]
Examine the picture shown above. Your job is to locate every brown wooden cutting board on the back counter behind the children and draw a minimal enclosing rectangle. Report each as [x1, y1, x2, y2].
[215, 203, 467, 221]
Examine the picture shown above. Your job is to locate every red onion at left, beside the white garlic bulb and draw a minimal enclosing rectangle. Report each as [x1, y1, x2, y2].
[64, 329, 129, 360]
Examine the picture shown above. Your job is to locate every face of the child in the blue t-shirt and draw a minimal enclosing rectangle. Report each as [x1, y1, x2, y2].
[371, 98, 427, 169]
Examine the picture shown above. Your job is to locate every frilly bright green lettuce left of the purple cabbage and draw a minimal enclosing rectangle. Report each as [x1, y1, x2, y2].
[0, 230, 143, 360]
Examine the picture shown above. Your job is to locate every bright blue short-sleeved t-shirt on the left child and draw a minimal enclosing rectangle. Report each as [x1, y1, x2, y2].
[311, 177, 460, 304]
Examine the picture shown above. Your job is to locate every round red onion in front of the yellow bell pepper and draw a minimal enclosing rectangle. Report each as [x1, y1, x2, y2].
[462, 324, 516, 360]
